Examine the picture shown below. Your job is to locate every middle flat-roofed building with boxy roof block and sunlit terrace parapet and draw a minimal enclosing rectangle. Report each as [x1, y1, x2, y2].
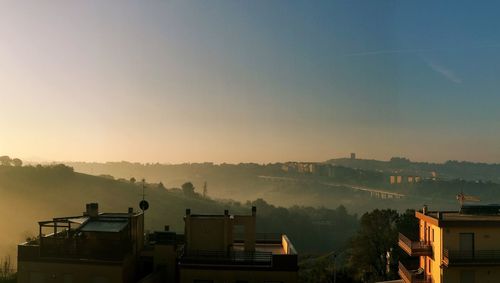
[178, 207, 298, 283]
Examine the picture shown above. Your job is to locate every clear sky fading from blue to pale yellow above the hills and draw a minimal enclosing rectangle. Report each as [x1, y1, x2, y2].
[0, 0, 500, 163]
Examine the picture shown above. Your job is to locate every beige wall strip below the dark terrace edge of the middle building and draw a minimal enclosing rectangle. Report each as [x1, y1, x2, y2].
[180, 269, 297, 283]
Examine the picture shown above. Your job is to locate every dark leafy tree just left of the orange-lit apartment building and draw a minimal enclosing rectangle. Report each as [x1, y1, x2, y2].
[349, 209, 399, 282]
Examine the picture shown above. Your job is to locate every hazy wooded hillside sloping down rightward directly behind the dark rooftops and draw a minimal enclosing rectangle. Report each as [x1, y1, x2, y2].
[0, 165, 357, 266]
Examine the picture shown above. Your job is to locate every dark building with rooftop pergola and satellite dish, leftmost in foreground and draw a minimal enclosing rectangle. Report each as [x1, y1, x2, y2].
[17, 203, 144, 283]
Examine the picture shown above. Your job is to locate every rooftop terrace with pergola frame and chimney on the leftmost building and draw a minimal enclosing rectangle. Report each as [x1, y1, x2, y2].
[18, 204, 142, 261]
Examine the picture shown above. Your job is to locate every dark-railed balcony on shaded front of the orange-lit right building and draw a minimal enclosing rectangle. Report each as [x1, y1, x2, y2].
[443, 249, 500, 266]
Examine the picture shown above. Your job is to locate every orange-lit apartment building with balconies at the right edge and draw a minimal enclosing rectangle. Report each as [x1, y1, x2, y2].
[399, 205, 500, 283]
